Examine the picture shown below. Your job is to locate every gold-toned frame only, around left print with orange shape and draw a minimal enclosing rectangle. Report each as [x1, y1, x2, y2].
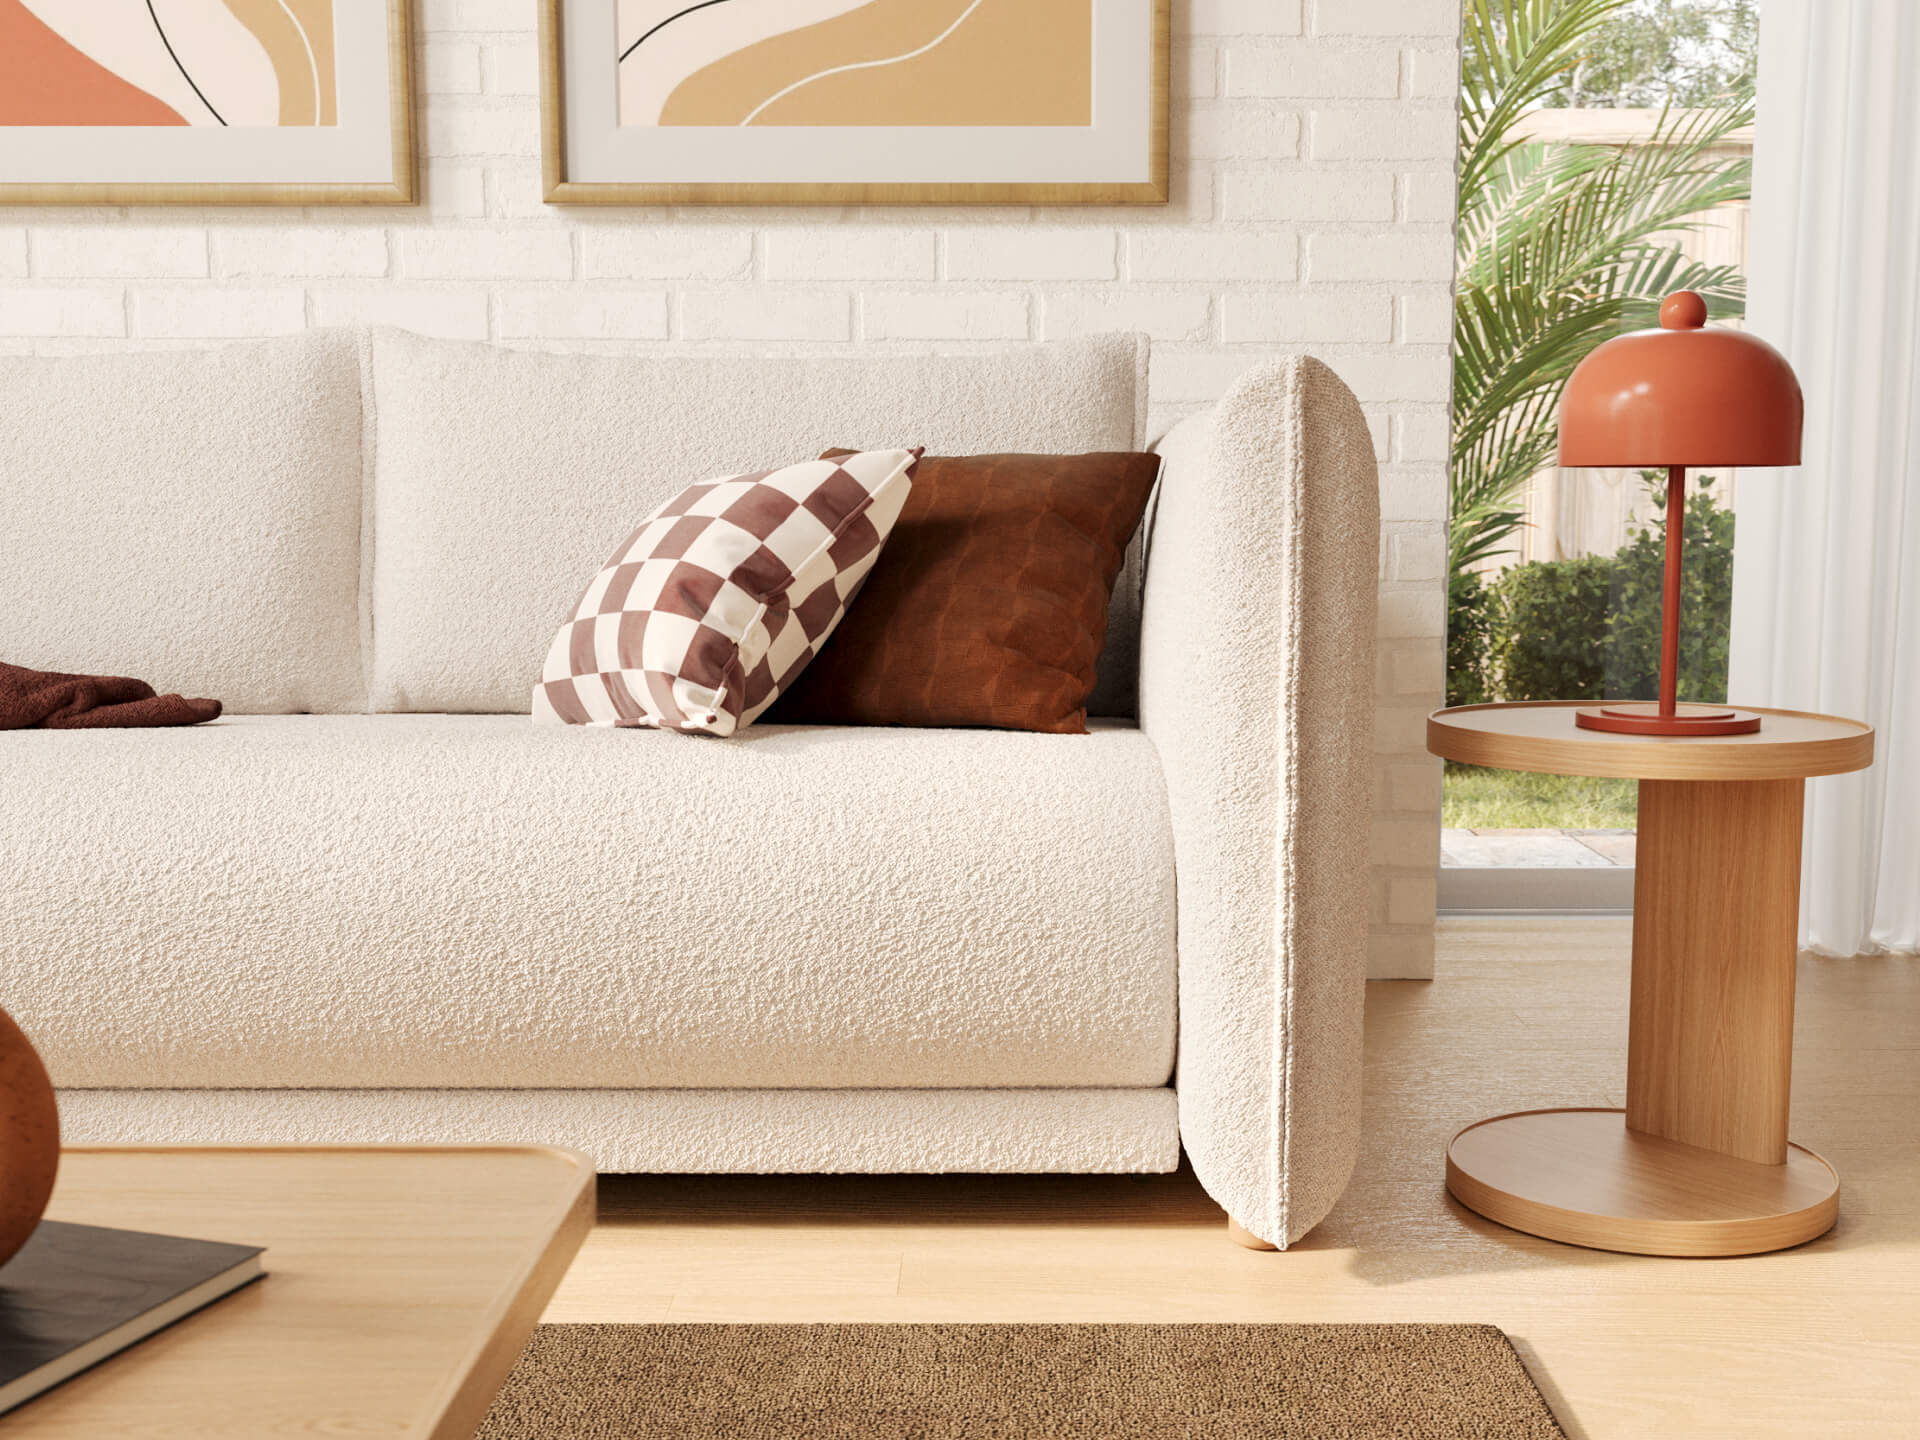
[0, 0, 419, 205]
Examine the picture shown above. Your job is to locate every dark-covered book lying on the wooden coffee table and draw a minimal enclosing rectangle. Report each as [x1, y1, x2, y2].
[0, 1219, 263, 1411]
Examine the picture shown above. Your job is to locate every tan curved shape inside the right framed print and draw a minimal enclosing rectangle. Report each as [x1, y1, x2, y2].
[660, 0, 1092, 127]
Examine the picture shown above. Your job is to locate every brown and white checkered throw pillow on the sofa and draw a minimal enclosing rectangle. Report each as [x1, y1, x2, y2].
[534, 449, 920, 735]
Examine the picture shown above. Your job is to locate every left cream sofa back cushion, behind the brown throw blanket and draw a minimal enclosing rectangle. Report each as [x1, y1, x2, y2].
[0, 330, 367, 714]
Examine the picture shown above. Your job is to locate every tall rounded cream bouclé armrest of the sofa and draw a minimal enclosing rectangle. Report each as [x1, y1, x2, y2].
[1140, 359, 1380, 1246]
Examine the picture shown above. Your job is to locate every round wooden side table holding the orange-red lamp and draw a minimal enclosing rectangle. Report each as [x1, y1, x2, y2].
[1427, 701, 1874, 1256]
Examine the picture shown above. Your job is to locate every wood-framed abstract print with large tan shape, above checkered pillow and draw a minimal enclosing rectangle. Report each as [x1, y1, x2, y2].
[540, 0, 1171, 205]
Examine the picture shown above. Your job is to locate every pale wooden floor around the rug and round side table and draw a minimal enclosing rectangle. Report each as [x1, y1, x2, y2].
[547, 916, 1920, 1440]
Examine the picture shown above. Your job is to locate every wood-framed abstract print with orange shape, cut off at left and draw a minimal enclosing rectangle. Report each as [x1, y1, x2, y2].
[0, 0, 415, 205]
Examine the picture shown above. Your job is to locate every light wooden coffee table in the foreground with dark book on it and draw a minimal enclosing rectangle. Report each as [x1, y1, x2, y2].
[0, 1146, 593, 1440]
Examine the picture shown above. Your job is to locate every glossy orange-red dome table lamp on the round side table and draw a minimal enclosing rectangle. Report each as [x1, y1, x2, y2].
[1559, 290, 1801, 735]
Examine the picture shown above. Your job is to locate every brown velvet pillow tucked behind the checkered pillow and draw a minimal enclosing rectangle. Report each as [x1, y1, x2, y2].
[766, 449, 1160, 735]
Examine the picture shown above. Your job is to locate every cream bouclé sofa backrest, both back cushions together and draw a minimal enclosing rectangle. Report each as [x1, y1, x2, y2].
[0, 330, 1146, 714]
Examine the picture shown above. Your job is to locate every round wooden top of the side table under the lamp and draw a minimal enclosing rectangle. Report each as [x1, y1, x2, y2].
[1427, 701, 1874, 780]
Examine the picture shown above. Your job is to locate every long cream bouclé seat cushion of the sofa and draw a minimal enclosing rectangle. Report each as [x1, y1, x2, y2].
[0, 716, 1175, 1089]
